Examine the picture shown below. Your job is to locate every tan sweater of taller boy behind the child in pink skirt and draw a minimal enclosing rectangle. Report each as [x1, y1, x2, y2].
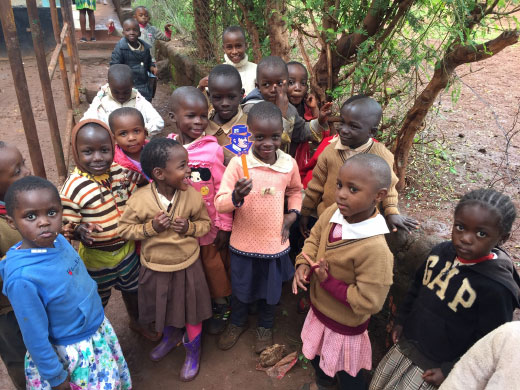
[301, 138, 399, 216]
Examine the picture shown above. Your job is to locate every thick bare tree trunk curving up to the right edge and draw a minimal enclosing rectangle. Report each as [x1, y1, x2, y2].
[394, 31, 520, 190]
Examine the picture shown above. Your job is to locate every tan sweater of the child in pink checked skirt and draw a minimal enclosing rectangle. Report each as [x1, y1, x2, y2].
[296, 204, 394, 327]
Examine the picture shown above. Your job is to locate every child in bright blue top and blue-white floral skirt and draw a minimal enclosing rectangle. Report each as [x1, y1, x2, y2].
[0, 176, 132, 390]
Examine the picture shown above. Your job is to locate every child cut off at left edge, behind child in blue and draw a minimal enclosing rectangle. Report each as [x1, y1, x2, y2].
[0, 141, 31, 390]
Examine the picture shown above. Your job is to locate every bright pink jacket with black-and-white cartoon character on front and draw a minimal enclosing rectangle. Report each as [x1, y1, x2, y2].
[168, 133, 233, 245]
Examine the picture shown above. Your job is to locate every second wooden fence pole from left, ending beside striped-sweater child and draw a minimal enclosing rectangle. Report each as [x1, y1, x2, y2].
[26, 0, 67, 181]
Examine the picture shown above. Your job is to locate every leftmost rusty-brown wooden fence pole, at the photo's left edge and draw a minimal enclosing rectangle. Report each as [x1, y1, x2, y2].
[0, 0, 47, 178]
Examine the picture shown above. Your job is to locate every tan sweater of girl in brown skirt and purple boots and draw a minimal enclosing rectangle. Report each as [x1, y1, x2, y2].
[117, 183, 211, 272]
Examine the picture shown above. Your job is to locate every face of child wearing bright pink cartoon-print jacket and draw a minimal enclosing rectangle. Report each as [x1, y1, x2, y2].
[171, 98, 208, 142]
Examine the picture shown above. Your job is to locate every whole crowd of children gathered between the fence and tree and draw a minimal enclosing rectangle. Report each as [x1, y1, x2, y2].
[0, 7, 520, 390]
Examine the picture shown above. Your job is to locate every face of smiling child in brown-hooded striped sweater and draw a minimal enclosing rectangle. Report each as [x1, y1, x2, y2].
[76, 125, 114, 176]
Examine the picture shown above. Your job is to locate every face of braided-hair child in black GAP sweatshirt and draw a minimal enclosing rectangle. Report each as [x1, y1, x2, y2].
[451, 203, 508, 260]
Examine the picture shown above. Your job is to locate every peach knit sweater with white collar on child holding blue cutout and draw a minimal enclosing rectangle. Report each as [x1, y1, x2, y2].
[215, 150, 303, 257]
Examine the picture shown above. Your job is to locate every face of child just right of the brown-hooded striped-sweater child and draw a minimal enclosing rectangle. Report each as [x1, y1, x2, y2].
[111, 115, 147, 157]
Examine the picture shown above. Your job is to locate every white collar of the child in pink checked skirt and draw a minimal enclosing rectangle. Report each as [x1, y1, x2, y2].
[329, 209, 390, 240]
